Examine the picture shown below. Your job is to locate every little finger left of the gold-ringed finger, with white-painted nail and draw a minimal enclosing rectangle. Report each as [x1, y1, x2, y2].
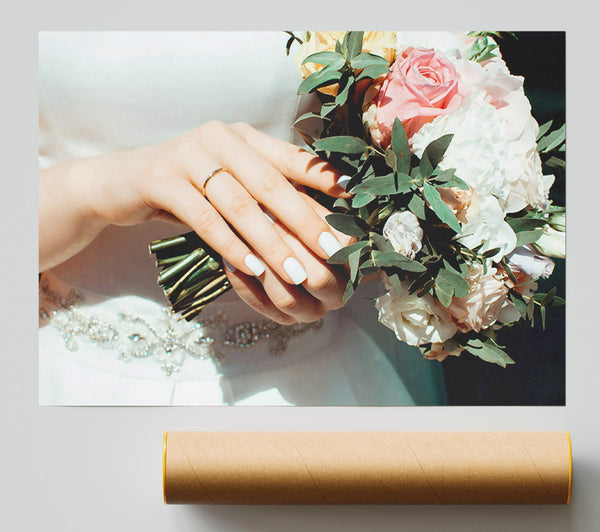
[145, 178, 265, 276]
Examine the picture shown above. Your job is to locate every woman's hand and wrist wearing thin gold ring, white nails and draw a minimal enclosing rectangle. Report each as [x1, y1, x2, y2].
[40, 122, 347, 321]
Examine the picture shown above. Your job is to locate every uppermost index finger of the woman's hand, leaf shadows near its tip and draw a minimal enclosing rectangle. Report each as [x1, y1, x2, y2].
[231, 123, 350, 198]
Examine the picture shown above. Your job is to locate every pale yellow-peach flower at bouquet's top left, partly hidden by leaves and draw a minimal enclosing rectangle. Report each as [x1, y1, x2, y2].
[294, 31, 396, 96]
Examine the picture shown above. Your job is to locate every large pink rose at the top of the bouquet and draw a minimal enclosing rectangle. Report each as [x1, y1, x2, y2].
[364, 48, 469, 148]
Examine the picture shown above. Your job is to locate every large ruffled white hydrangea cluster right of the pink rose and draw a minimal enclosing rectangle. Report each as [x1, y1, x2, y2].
[413, 54, 554, 213]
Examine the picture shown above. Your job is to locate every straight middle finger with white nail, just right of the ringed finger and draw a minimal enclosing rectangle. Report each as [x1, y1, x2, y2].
[200, 124, 341, 271]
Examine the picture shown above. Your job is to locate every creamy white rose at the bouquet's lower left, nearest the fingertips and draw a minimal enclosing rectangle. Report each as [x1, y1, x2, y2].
[375, 280, 457, 345]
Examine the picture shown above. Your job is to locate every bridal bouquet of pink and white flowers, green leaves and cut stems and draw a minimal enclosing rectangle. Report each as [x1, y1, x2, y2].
[151, 32, 565, 366]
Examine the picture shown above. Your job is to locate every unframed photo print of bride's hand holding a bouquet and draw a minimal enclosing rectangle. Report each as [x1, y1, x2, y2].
[38, 31, 565, 406]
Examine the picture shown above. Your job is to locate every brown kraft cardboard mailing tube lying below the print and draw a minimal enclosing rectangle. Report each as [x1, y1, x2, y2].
[163, 432, 572, 504]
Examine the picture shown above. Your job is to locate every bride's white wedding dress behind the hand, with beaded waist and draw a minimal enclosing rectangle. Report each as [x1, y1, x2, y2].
[39, 32, 446, 405]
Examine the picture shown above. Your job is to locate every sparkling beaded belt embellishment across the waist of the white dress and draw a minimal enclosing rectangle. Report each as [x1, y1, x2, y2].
[39, 275, 323, 376]
